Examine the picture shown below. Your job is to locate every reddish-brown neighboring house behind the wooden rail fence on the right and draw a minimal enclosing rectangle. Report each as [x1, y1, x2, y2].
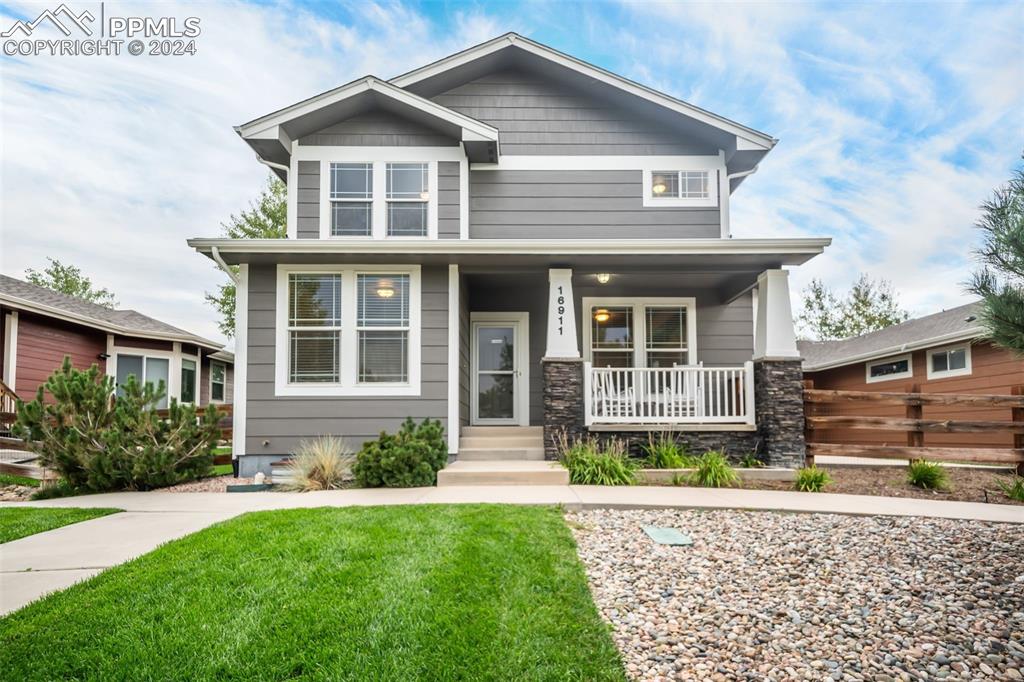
[798, 303, 1024, 447]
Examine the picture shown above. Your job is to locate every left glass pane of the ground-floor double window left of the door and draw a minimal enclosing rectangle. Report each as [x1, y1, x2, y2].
[288, 273, 342, 383]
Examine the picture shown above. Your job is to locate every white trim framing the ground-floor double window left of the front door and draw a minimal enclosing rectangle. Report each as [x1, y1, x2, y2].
[274, 264, 422, 396]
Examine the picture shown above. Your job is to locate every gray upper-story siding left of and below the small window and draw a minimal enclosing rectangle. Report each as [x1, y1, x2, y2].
[469, 170, 721, 239]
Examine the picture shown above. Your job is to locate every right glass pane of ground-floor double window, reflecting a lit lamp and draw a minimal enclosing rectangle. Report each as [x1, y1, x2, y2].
[355, 274, 410, 384]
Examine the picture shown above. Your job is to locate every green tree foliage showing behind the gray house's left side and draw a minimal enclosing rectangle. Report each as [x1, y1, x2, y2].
[206, 174, 288, 336]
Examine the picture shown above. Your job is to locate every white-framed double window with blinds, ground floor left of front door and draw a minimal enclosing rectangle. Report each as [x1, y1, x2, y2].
[275, 265, 420, 395]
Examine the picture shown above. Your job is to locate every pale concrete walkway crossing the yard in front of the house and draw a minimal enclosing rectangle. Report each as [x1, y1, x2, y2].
[0, 485, 1024, 614]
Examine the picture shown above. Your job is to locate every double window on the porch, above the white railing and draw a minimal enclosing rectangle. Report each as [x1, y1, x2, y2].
[584, 298, 696, 368]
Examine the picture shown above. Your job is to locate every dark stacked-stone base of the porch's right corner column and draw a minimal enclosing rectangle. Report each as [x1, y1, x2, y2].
[754, 359, 807, 468]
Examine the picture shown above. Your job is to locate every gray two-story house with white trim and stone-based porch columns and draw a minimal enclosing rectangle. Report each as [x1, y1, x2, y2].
[189, 34, 829, 473]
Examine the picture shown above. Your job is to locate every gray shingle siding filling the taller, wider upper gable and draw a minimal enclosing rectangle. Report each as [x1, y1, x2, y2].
[432, 71, 718, 156]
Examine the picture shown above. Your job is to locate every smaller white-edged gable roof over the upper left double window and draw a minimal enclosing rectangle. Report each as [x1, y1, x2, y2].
[234, 76, 498, 165]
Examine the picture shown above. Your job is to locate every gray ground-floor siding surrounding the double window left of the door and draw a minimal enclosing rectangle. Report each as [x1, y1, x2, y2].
[246, 265, 447, 455]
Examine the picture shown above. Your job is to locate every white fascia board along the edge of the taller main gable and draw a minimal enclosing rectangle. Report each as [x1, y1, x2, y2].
[390, 33, 778, 152]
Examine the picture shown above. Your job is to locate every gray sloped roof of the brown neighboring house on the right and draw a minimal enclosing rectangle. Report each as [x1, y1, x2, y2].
[797, 301, 985, 372]
